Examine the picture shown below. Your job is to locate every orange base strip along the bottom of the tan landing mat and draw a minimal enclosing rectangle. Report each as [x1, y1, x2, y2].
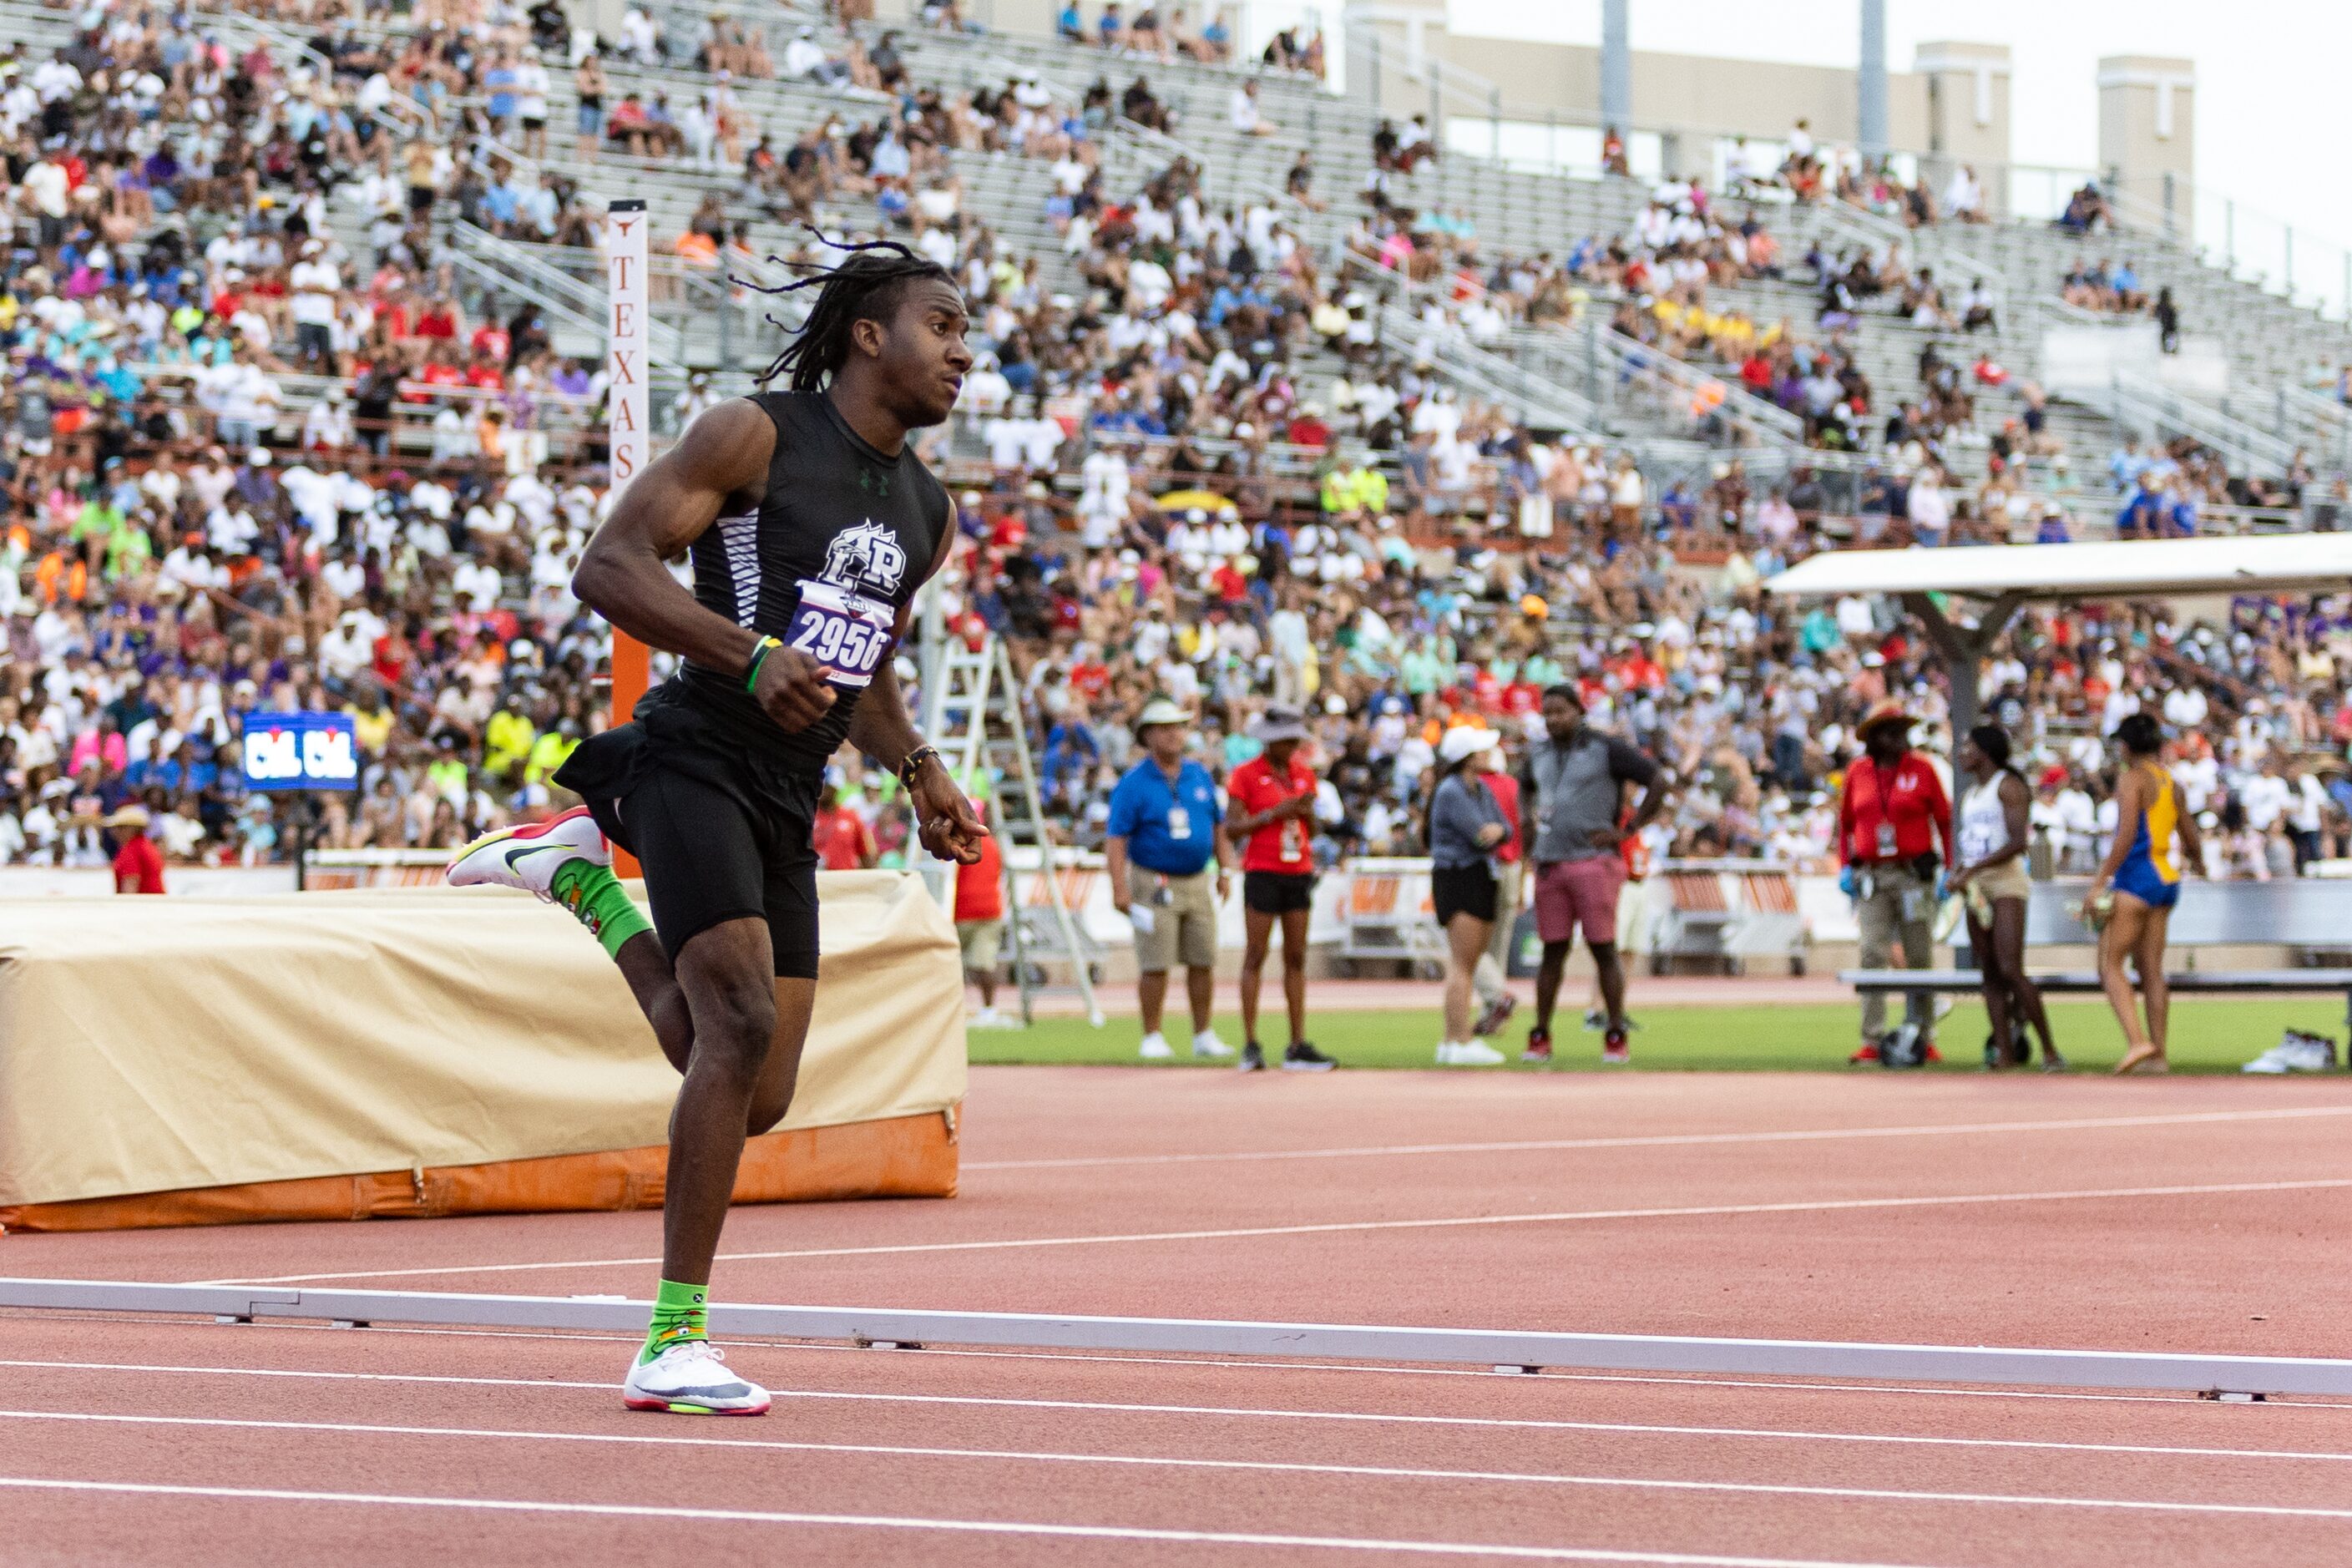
[0, 1112, 955, 1232]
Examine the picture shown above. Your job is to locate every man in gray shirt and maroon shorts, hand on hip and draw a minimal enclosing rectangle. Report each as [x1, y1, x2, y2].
[1520, 686, 1665, 1063]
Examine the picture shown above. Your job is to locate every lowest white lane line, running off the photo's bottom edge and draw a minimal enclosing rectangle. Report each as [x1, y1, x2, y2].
[0, 1476, 1947, 1568]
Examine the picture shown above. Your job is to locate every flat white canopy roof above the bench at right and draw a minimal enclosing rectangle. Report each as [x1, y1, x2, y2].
[1764, 534, 2352, 599]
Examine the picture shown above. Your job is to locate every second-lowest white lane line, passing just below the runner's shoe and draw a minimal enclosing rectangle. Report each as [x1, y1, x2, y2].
[0, 1410, 2352, 1519]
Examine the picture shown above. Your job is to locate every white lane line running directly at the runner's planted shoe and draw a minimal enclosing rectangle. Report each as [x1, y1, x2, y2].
[0, 1361, 2352, 1474]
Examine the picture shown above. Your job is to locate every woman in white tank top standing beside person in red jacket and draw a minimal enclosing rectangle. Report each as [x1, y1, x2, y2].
[1952, 724, 2065, 1072]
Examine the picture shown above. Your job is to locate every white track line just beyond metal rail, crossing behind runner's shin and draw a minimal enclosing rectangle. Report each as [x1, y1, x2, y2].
[186, 1178, 2352, 1286]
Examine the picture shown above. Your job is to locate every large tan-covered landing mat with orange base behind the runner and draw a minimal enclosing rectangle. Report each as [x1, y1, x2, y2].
[0, 873, 964, 1225]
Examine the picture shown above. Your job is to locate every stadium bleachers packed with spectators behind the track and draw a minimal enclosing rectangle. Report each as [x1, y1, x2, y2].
[0, 0, 2352, 893]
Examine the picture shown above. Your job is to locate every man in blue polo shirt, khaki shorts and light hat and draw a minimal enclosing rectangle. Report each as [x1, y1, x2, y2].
[1103, 695, 1232, 1063]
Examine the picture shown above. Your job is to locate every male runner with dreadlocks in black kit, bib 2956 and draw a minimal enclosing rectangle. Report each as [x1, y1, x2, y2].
[449, 245, 988, 1415]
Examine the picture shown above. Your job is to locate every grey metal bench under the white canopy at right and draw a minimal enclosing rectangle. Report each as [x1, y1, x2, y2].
[1837, 877, 2352, 1025]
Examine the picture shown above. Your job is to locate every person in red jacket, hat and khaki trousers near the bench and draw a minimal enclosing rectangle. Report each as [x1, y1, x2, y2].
[1837, 701, 1952, 1067]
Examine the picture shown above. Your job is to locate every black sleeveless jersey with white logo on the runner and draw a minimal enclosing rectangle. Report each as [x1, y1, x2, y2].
[656, 392, 955, 778]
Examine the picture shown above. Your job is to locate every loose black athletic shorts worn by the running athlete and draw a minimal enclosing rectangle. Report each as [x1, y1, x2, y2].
[555, 694, 818, 980]
